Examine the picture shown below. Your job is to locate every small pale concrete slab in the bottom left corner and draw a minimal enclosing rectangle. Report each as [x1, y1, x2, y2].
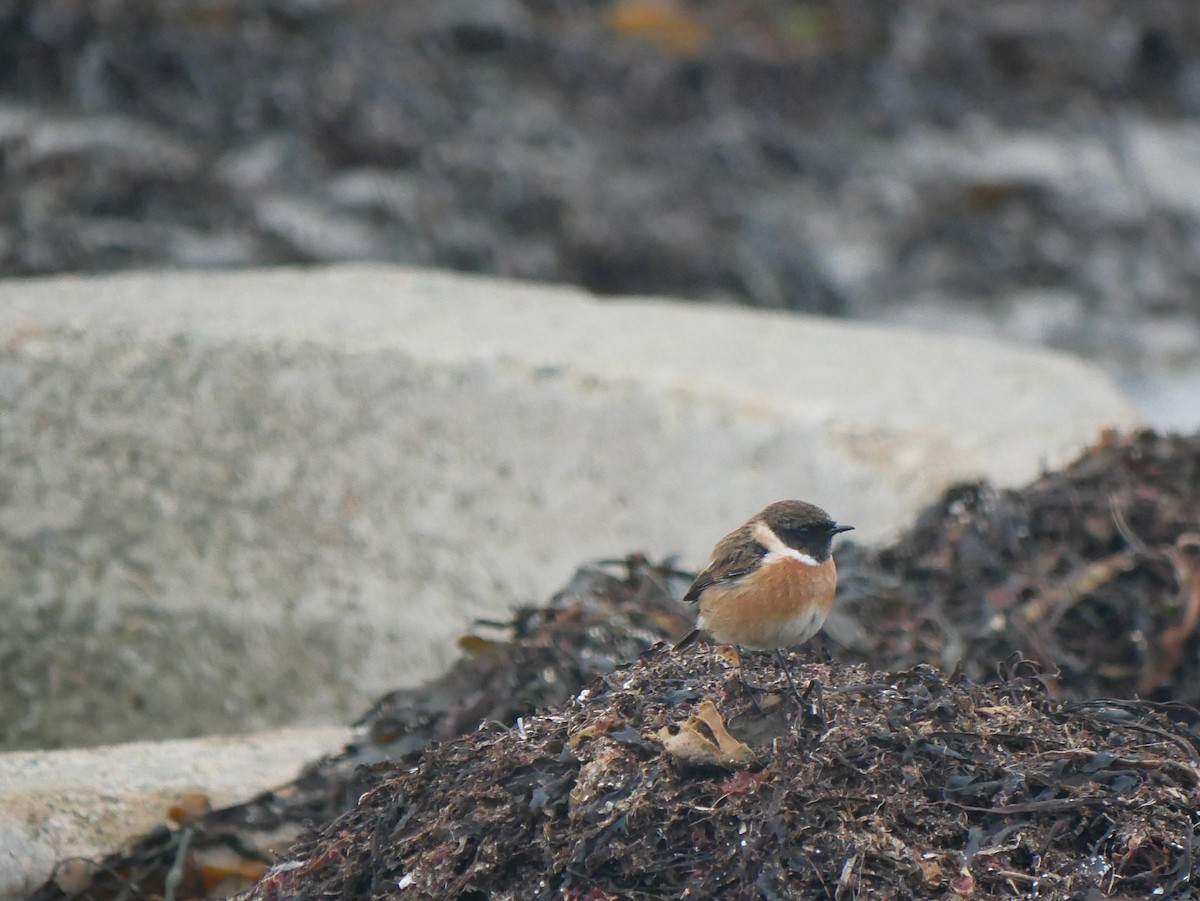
[0, 727, 349, 901]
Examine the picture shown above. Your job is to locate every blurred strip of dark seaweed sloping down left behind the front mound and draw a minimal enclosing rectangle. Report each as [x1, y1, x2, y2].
[32, 554, 695, 901]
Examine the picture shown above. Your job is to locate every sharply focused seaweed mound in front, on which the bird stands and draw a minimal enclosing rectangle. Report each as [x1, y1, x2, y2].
[251, 648, 1200, 901]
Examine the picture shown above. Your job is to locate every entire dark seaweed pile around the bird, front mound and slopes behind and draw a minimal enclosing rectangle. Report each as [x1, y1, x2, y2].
[28, 432, 1200, 900]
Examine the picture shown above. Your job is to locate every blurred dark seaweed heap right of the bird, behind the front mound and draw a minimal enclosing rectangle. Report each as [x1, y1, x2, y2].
[827, 432, 1200, 707]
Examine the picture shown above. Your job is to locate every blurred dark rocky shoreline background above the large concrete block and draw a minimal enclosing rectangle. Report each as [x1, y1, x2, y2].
[0, 0, 1200, 427]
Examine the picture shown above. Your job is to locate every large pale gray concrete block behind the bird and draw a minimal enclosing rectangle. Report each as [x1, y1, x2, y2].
[0, 266, 1135, 747]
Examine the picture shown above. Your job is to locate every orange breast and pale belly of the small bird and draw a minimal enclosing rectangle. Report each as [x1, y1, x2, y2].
[697, 557, 838, 650]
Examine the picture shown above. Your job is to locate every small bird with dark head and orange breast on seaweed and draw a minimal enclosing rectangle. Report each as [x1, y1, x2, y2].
[674, 500, 854, 683]
